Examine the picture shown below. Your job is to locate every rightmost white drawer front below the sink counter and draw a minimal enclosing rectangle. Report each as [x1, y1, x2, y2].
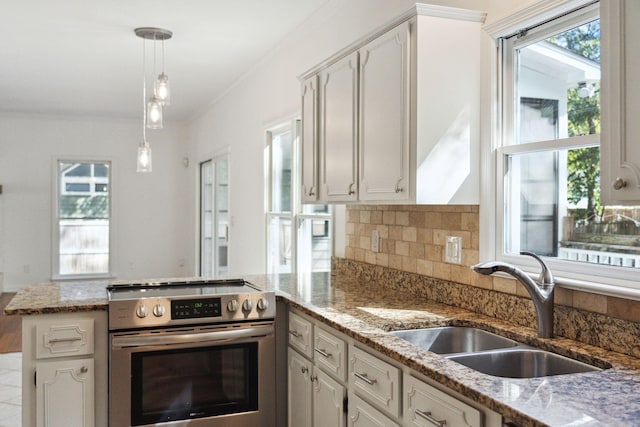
[403, 374, 482, 427]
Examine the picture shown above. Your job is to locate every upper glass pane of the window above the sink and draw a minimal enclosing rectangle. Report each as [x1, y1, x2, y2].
[515, 20, 600, 144]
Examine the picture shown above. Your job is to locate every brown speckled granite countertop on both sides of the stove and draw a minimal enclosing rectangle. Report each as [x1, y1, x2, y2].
[5, 273, 640, 426]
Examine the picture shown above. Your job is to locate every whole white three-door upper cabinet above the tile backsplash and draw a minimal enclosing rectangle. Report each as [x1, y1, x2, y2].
[301, 4, 484, 204]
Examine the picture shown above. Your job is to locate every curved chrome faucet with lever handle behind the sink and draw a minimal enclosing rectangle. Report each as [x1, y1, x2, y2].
[471, 251, 555, 338]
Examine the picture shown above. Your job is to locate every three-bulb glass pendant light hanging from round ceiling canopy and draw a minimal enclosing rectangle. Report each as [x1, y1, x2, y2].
[134, 27, 173, 172]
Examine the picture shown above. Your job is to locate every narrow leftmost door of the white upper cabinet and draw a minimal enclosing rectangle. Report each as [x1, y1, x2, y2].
[300, 76, 318, 202]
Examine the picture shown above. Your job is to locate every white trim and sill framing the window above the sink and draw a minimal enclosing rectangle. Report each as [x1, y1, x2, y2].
[479, 0, 640, 300]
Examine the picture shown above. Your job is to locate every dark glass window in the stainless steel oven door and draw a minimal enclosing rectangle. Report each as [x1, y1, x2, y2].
[131, 342, 258, 425]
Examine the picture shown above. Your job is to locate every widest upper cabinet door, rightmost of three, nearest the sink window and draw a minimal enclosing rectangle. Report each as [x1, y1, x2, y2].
[359, 23, 410, 201]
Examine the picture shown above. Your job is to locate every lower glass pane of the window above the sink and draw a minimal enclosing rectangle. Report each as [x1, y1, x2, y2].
[505, 147, 640, 268]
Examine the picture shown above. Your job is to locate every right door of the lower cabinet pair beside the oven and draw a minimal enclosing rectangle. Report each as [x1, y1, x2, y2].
[313, 369, 345, 427]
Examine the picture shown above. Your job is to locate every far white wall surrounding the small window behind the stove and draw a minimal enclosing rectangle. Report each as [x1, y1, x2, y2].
[0, 115, 194, 292]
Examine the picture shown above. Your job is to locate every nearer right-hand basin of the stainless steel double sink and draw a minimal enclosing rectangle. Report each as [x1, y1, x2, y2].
[447, 348, 600, 378]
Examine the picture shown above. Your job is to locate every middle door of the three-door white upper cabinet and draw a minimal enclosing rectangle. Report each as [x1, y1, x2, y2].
[320, 52, 358, 202]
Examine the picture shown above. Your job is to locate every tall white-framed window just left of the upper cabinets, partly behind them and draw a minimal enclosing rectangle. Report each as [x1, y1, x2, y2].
[265, 120, 332, 273]
